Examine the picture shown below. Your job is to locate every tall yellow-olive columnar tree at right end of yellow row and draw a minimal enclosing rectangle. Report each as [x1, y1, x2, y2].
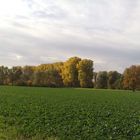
[77, 59, 93, 88]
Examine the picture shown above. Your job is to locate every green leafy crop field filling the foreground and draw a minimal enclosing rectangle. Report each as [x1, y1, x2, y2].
[0, 86, 140, 140]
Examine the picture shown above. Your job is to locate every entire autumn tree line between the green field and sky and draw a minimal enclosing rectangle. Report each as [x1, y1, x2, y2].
[0, 57, 140, 90]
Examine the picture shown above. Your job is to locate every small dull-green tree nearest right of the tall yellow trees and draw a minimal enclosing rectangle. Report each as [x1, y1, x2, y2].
[96, 71, 108, 89]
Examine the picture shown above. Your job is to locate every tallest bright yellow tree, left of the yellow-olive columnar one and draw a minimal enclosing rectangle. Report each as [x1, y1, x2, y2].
[62, 57, 81, 87]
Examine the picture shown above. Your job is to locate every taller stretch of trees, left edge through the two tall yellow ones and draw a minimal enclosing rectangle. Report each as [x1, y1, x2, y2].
[0, 57, 93, 87]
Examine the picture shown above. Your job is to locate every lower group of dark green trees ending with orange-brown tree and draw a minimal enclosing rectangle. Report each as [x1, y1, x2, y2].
[94, 65, 140, 91]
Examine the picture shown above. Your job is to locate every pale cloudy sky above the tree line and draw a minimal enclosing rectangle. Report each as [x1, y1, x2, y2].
[0, 0, 140, 72]
